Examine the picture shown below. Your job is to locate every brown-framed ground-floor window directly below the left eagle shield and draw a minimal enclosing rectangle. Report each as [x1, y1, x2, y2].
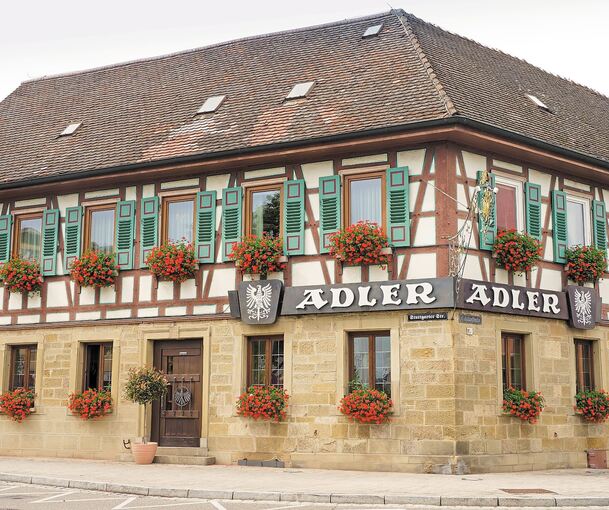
[247, 336, 284, 387]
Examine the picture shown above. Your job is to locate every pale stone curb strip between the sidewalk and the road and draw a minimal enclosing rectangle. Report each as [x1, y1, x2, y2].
[0, 472, 609, 507]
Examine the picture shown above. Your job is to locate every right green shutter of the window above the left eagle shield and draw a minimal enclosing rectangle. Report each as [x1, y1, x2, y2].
[283, 179, 305, 255]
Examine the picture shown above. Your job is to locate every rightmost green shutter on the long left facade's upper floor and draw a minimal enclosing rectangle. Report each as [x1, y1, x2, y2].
[387, 166, 410, 246]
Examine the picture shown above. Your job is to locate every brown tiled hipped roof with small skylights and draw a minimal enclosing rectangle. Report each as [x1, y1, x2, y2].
[0, 11, 609, 185]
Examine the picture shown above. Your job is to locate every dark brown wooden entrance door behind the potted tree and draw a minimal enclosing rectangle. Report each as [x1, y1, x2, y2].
[152, 340, 202, 446]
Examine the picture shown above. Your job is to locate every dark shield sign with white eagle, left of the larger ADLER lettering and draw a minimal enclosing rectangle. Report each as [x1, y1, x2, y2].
[239, 280, 283, 324]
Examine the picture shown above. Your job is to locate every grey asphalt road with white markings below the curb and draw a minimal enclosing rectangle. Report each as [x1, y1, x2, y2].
[0, 482, 599, 510]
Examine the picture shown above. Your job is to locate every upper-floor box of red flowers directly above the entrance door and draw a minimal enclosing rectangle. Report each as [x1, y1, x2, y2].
[146, 242, 199, 283]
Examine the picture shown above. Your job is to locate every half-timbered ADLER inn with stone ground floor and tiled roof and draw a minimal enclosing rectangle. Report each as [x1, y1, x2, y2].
[0, 11, 609, 472]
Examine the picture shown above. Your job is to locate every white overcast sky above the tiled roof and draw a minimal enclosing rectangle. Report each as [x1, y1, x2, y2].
[0, 0, 609, 99]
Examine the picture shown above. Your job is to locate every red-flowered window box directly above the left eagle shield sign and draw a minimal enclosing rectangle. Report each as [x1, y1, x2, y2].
[228, 234, 287, 279]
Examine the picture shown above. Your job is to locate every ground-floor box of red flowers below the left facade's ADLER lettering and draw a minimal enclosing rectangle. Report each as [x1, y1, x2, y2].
[338, 384, 393, 425]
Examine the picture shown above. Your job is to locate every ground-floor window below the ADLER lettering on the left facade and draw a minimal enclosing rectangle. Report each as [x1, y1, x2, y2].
[349, 331, 391, 396]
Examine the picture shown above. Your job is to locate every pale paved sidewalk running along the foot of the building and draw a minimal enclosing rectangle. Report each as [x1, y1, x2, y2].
[0, 457, 609, 506]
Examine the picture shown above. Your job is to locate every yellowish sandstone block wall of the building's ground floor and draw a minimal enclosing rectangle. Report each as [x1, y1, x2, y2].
[0, 310, 609, 473]
